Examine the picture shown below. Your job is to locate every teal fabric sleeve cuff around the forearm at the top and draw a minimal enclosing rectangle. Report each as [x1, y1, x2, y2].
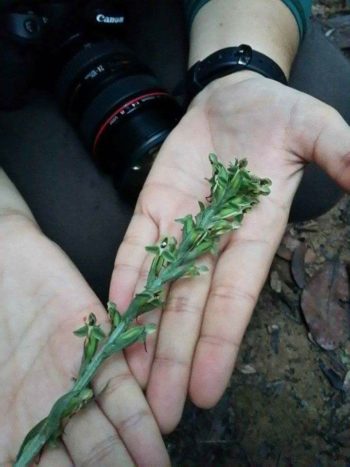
[183, 0, 312, 38]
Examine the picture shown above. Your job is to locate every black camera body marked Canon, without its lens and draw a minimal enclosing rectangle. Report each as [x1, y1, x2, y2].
[0, 0, 126, 110]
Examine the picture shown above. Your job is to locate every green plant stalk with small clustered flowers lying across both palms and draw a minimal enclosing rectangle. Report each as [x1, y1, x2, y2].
[14, 154, 271, 467]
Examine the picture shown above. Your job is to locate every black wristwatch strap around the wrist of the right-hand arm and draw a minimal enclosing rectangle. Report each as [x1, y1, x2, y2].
[186, 44, 288, 102]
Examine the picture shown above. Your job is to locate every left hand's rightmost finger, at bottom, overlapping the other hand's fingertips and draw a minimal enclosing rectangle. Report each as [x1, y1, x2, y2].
[94, 356, 169, 467]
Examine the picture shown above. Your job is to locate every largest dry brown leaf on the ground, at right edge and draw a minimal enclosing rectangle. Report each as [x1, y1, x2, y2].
[301, 261, 350, 350]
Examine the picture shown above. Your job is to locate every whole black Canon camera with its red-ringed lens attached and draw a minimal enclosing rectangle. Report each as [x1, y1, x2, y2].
[0, 0, 182, 195]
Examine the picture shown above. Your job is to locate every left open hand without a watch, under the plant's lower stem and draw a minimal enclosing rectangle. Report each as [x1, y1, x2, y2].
[0, 171, 169, 467]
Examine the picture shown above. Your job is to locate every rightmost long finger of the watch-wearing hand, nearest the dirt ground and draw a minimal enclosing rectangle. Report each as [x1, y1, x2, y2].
[189, 199, 288, 408]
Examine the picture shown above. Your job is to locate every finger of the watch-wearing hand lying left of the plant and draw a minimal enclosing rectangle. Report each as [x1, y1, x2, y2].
[109, 210, 158, 311]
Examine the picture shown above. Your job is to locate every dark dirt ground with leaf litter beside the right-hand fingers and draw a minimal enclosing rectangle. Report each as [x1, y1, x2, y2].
[166, 0, 350, 467]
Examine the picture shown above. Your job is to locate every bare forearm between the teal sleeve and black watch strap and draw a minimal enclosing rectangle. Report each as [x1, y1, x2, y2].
[189, 0, 299, 77]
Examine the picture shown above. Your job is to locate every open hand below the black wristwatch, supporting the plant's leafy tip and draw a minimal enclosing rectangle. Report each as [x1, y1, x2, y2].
[110, 71, 350, 432]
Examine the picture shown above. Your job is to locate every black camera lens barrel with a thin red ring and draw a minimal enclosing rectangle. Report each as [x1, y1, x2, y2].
[57, 40, 181, 195]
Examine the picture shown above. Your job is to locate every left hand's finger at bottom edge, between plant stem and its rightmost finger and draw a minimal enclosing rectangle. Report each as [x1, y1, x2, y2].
[63, 402, 134, 467]
